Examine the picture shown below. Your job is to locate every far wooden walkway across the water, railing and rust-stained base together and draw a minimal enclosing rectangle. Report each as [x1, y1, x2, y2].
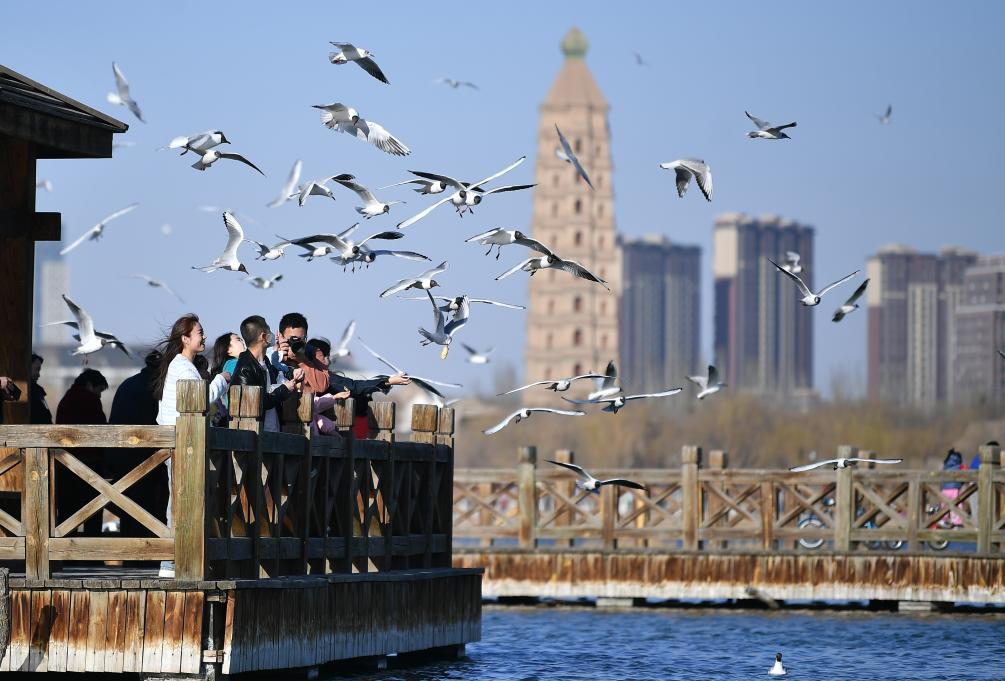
[453, 447, 1005, 604]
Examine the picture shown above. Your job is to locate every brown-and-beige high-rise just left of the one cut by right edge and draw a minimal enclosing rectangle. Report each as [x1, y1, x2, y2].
[866, 245, 977, 408]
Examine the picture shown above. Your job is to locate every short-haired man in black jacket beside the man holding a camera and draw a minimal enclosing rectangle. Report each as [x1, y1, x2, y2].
[230, 314, 304, 432]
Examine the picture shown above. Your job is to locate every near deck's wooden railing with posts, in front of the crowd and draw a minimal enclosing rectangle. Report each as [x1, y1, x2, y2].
[0, 381, 453, 580]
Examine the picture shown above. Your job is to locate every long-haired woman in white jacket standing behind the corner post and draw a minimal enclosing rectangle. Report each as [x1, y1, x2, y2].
[154, 314, 230, 578]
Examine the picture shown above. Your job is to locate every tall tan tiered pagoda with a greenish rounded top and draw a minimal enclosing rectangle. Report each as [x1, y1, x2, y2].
[525, 28, 620, 401]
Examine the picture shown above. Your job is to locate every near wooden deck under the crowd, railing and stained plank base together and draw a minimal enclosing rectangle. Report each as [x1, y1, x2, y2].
[0, 381, 481, 678]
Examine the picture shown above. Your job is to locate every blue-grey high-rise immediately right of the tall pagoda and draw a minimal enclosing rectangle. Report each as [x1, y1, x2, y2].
[618, 236, 705, 393]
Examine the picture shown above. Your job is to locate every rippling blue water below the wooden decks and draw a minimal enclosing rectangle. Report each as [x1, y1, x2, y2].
[329, 608, 1005, 681]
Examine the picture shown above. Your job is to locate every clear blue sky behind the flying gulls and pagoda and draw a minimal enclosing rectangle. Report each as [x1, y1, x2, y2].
[0, 2, 1005, 390]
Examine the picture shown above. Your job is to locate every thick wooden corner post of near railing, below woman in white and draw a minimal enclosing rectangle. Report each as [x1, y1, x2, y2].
[171, 381, 209, 580]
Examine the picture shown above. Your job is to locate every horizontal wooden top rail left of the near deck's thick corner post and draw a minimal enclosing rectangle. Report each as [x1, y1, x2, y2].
[0, 425, 175, 449]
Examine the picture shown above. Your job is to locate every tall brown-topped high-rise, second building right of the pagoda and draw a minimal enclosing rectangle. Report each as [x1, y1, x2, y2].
[713, 213, 816, 395]
